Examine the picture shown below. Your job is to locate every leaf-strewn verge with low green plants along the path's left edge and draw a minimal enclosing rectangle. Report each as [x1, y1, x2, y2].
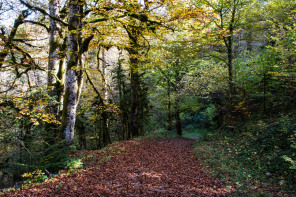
[0, 142, 126, 195]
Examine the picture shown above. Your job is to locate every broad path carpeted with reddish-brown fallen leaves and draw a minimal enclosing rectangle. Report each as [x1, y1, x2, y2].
[4, 139, 233, 196]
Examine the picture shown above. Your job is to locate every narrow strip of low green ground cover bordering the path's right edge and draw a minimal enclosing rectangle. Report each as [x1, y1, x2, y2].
[194, 136, 267, 195]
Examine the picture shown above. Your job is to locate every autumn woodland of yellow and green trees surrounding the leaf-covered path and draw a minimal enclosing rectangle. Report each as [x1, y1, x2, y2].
[0, 0, 296, 196]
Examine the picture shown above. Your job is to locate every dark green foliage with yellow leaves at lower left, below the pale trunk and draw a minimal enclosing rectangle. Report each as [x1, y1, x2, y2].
[0, 138, 82, 187]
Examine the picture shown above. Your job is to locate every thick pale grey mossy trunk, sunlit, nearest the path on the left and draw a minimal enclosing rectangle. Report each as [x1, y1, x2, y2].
[61, 0, 83, 145]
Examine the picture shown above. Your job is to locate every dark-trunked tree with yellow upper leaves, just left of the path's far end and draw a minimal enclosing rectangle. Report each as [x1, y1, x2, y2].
[121, 1, 163, 136]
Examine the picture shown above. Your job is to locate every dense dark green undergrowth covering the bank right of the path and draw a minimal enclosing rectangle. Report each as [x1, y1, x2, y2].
[194, 117, 296, 196]
